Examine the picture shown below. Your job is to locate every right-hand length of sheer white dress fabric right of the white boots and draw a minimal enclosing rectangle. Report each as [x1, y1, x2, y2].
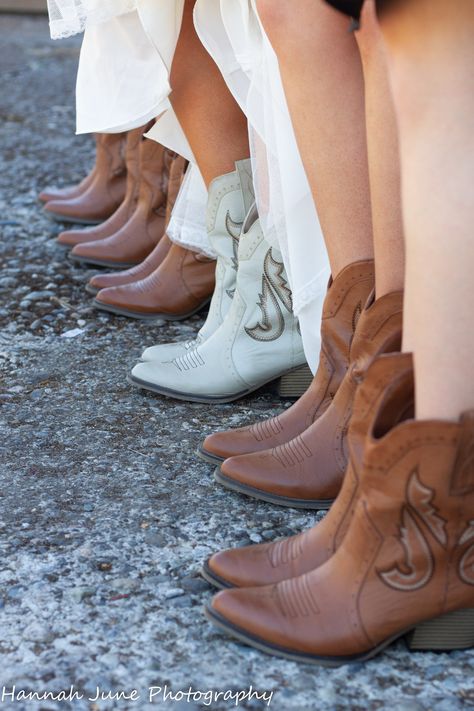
[194, 0, 329, 371]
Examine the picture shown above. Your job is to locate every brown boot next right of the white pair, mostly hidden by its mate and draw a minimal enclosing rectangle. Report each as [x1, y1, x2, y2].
[198, 260, 374, 464]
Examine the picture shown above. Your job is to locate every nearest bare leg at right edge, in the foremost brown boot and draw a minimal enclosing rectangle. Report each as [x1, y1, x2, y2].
[382, 0, 474, 419]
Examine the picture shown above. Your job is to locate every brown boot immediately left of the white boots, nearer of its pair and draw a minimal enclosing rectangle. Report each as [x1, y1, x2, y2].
[94, 244, 215, 319]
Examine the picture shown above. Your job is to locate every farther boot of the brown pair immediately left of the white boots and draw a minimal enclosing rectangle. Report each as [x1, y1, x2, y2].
[86, 152, 187, 294]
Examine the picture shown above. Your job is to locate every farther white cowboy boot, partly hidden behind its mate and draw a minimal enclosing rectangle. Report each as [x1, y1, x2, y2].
[141, 159, 255, 362]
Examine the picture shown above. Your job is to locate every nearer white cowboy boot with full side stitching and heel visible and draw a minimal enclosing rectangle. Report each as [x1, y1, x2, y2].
[129, 210, 310, 403]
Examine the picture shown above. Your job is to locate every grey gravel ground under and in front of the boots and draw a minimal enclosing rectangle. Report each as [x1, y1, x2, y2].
[0, 16, 474, 711]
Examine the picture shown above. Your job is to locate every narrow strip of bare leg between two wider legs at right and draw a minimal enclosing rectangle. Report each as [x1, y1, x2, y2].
[356, 0, 405, 297]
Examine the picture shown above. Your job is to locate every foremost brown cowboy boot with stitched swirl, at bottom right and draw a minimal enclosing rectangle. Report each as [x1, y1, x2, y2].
[208, 362, 474, 666]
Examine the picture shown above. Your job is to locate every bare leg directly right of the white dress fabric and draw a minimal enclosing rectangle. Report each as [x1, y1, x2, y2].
[258, 0, 373, 274]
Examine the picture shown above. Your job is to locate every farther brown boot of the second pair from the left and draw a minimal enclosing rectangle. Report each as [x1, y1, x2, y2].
[57, 126, 146, 247]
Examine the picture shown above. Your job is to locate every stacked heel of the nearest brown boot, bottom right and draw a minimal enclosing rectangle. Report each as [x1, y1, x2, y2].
[405, 608, 474, 652]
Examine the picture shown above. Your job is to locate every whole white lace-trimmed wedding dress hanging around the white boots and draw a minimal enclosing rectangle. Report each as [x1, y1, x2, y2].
[48, 0, 329, 370]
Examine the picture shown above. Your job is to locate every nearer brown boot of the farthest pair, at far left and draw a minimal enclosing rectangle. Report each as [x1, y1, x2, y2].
[44, 133, 127, 225]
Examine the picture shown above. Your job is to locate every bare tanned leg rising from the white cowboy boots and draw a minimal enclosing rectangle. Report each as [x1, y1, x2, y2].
[171, 0, 250, 185]
